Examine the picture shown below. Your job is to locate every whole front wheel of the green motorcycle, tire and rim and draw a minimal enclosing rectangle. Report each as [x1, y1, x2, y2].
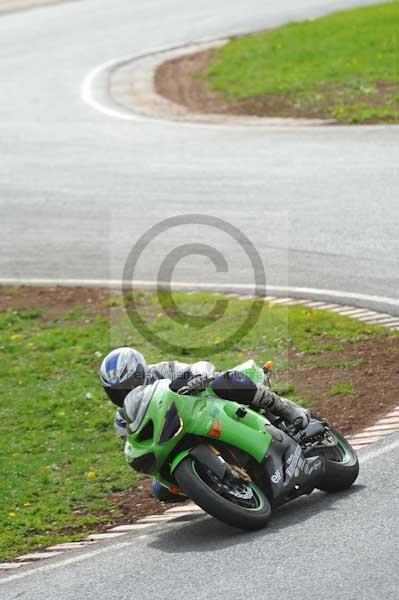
[175, 456, 271, 530]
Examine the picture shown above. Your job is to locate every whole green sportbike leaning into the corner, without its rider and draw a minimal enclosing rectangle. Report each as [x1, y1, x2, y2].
[125, 360, 359, 530]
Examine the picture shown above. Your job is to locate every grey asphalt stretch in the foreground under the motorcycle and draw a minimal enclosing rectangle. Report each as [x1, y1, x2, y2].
[0, 436, 399, 600]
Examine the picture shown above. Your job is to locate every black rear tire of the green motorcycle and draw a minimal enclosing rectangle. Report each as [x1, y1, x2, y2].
[318, 429, 359, 494]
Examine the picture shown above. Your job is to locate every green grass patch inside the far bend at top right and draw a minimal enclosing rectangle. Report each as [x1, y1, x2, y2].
[207, 0, 399, 122]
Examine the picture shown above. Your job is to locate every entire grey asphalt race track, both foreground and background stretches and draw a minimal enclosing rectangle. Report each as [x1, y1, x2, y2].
[0, 0, 399, 600]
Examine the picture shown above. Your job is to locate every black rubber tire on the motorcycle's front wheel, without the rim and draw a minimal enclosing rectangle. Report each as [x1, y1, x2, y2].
[175, 456, 271, 530]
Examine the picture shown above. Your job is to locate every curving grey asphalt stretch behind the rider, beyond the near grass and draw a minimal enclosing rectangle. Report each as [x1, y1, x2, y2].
[0, 0, 399, 312]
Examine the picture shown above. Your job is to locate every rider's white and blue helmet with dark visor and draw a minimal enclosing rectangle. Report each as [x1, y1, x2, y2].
[100, 348, 147, 406]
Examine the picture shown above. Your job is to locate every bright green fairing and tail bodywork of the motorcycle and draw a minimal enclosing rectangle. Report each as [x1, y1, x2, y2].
[125, 360, 272, 486]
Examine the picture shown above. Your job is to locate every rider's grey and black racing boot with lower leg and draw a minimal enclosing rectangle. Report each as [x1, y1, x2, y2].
[252, 385, 310, 429]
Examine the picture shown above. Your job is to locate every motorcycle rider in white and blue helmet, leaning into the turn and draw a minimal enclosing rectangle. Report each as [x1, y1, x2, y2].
[100, 347, 310, 502]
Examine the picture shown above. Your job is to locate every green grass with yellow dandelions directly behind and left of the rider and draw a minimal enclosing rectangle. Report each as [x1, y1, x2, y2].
[0, 292, 392, 560]
